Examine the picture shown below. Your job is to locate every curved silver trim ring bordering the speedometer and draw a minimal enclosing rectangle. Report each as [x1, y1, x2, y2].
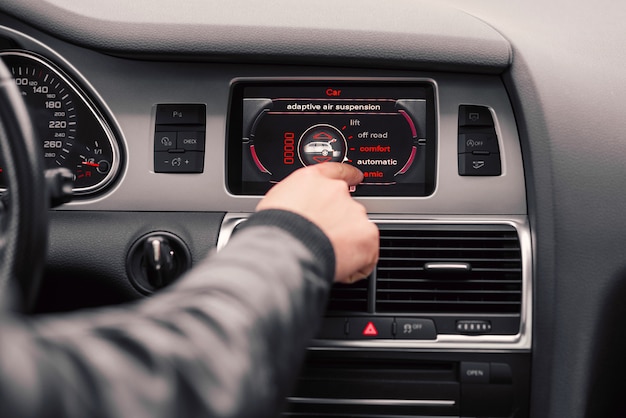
[0, 49, 121, 196]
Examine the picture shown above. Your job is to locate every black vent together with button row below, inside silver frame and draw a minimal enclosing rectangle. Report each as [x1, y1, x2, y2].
[223, 216, 528, 339]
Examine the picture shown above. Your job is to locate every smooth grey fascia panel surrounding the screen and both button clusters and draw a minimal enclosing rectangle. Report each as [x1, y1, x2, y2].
[0, 18, 526, 216]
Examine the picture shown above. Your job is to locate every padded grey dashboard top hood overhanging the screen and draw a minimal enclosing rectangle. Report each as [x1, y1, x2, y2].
[1, 0, 511, 72]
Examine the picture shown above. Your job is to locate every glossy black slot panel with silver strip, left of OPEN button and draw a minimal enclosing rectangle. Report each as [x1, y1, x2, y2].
[283, 353, 456, 418]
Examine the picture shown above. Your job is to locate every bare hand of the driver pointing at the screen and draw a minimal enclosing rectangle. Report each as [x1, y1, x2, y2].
[256, 162, 379, 283]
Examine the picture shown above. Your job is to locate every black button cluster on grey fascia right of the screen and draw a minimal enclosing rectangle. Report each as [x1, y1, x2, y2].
[458, 105, 502, 176]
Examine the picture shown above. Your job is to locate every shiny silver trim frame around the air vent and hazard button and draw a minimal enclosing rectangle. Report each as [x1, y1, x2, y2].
[217, 213, 533, 352]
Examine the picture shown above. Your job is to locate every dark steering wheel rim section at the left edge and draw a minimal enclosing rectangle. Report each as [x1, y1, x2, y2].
[0, 61, 48, 311]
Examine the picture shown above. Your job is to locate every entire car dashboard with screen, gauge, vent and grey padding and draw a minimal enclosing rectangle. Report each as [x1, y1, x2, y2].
[0, 0, 626, 418]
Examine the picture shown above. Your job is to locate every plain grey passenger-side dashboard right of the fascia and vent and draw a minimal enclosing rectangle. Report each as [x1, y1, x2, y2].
[446, 0, 626, 417]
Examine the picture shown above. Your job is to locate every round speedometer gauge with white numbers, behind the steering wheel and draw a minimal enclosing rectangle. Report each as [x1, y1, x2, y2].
[0, 51, 120, 196]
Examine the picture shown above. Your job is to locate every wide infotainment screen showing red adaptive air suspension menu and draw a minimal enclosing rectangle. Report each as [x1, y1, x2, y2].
[227, 81, 437, 196]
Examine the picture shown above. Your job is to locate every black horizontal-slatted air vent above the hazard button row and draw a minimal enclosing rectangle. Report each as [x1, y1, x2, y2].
[327, 224, 522, 316]
